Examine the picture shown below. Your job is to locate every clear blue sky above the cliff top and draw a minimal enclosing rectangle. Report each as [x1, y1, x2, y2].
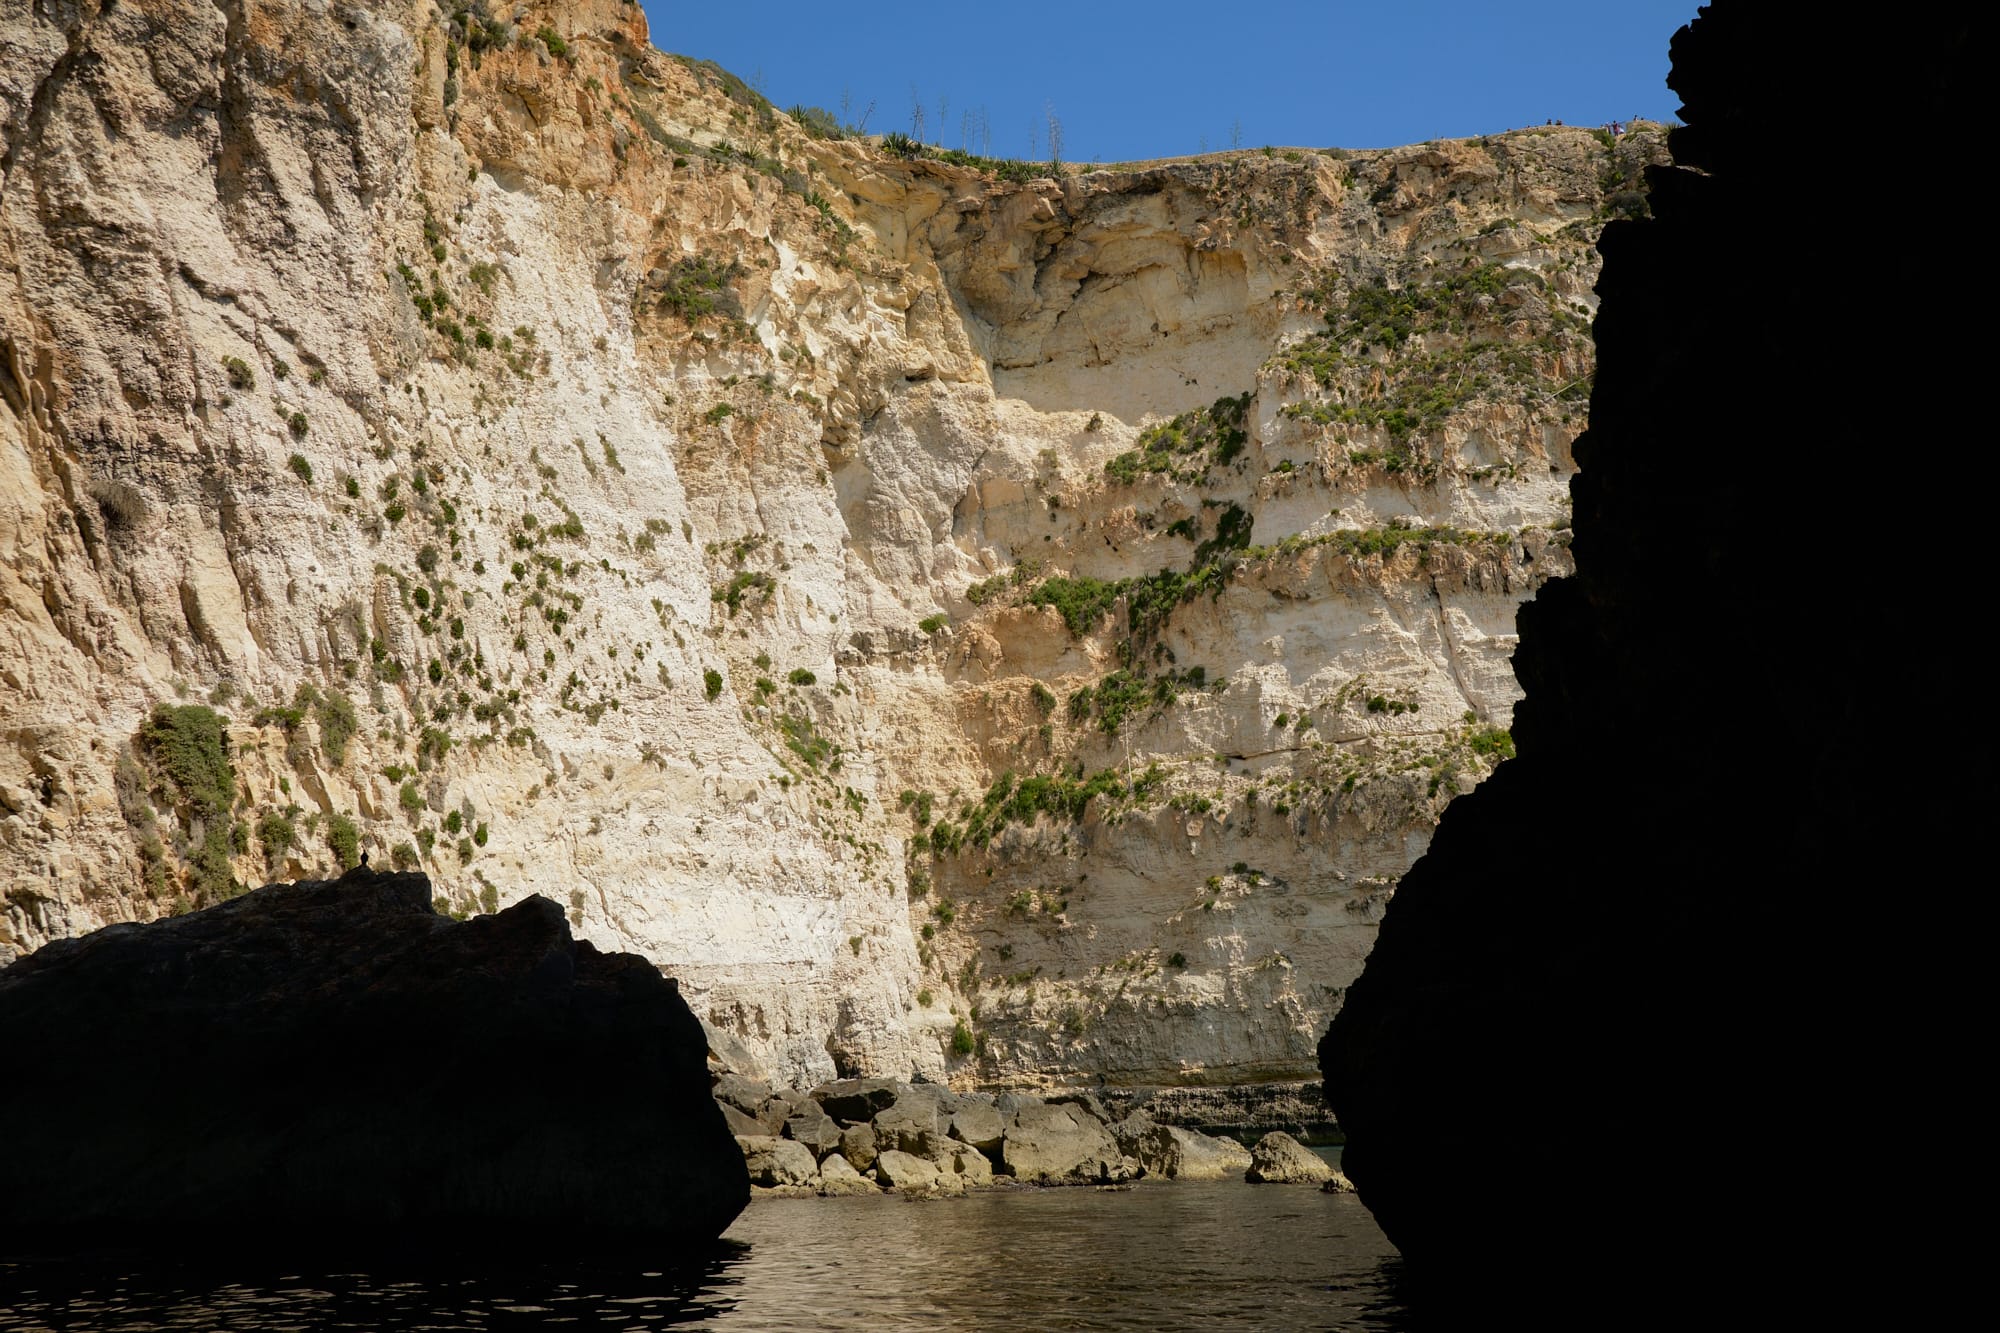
[642, 0, 1698, 162]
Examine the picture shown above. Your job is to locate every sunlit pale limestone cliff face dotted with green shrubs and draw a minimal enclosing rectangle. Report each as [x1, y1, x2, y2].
[0, 0, 1660, 1083]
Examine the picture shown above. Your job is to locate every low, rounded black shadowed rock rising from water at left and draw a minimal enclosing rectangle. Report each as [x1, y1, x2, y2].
[0, 875, 750, 1261]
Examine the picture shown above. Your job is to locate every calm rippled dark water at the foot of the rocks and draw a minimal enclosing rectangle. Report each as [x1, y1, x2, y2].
[0, 1181, 1408, 1333]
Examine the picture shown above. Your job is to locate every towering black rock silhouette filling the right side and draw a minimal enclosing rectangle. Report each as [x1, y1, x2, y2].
[1320, 0, 1994, 1296]
